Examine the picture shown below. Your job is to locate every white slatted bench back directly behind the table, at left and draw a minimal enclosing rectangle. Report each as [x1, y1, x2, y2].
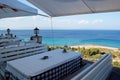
[0, 44, 47, 62]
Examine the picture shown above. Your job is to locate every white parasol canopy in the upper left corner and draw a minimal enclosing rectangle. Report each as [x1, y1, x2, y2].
[0, 0, 38, 18]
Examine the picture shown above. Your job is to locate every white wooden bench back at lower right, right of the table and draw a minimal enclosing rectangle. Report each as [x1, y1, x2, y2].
[71, 54, 112, 80]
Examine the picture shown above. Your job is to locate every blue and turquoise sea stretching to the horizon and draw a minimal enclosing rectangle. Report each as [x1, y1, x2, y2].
[0, 30, 120, 48]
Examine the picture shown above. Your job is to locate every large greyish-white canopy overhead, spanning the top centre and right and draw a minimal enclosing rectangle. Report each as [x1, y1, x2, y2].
[29, 0, 120, 17]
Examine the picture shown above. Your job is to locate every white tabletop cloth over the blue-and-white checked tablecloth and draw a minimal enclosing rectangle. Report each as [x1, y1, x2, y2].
[7, 49, 81, 77]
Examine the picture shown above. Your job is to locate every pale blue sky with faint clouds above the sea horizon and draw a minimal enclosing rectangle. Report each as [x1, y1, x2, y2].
[0, 0, 120, 30]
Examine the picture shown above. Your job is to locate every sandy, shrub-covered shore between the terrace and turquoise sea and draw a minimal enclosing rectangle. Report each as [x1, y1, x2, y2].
[48, 46, 120, 67]
